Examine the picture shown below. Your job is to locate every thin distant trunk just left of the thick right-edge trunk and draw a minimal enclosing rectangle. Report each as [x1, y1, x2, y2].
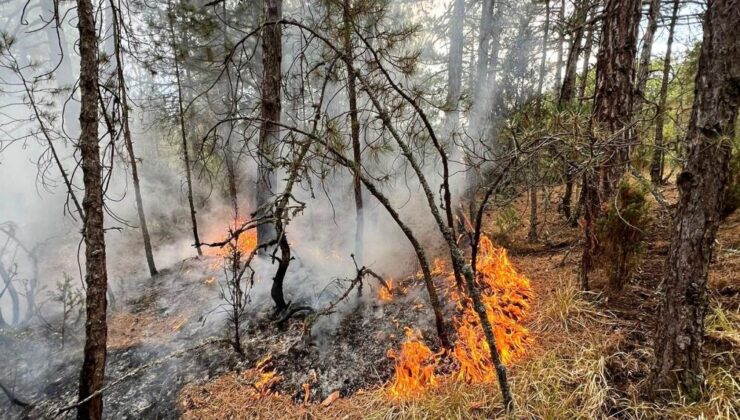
[650, 0, 681, 184]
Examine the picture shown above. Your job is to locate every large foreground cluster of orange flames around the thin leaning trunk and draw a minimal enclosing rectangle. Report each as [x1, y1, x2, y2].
[389, 236, 534, 397]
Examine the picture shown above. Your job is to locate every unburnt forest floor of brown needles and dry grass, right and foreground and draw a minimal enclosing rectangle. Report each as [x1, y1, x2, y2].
[179, 182, 740, 419]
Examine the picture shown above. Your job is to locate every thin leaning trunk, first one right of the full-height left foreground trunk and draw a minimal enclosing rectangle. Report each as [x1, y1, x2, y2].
[110, 0, 157, 276]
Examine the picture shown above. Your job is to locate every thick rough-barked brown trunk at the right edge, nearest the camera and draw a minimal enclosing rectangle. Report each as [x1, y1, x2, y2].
[650, 0, 740, 400]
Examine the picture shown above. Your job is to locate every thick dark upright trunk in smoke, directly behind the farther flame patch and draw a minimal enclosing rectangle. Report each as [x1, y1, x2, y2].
[255, 0, 283, 248]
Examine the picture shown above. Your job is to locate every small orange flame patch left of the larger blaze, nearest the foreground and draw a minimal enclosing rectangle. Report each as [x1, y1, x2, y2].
[388, 328, 441, 398]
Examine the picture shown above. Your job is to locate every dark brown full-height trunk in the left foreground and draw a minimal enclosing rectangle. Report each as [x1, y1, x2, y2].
[77, 0, 108, 420]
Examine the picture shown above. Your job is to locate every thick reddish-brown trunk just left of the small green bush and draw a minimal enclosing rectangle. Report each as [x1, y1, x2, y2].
[581, 0, 641, 286]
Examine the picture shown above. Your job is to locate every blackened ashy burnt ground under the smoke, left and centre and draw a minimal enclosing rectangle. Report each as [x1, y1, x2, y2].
[0, 253, 442, 419]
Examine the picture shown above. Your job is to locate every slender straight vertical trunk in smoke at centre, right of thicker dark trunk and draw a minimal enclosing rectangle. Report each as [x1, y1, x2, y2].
[342, 0, 365, 266]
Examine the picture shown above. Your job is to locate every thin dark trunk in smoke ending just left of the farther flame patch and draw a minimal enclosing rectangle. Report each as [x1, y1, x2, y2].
[168, 3, 203, 256]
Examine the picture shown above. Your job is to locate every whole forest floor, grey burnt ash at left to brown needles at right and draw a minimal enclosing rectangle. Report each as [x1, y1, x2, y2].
[0, 181, 740, 419]
